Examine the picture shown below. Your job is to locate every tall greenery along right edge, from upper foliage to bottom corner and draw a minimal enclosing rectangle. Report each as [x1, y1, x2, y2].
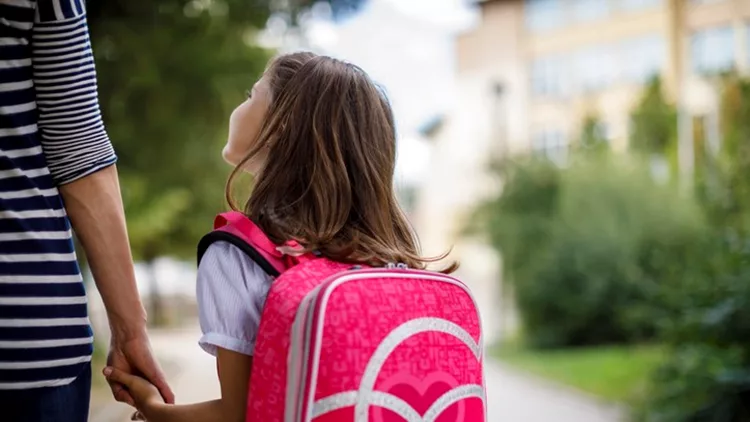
[638, 77, 750, 422]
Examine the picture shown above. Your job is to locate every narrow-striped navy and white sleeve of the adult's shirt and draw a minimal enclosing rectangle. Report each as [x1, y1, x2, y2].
[31, 0, 117, 185]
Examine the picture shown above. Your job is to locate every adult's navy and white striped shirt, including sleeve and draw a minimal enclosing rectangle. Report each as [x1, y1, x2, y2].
[0, 0, 116, 390]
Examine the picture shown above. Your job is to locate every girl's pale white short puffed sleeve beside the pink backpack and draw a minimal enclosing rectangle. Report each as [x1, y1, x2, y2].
[197, 242, 271, 356]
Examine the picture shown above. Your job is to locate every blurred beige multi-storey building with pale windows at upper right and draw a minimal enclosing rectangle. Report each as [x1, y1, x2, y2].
[457, 0, 750, 157]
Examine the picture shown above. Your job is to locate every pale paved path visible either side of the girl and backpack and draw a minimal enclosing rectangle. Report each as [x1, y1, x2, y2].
[91, 327, 623, 422]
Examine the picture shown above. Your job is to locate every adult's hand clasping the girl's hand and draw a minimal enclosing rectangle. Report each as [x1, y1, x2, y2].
[107, 330, 174, 406]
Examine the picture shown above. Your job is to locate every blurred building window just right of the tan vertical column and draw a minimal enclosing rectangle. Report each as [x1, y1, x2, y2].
[690, 26, 735, 74]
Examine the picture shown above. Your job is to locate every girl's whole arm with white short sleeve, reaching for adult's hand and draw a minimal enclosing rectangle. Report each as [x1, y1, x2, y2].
[105, 242, 271, 422]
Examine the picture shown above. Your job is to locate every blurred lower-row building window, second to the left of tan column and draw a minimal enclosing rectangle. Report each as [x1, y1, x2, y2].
[575, 47, 617, 92]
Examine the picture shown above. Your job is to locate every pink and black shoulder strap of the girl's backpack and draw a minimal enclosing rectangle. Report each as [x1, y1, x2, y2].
[198, 211, 288, 277]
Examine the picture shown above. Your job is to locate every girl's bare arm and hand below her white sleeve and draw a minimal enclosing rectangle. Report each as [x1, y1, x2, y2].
[104, 348, 253, 422]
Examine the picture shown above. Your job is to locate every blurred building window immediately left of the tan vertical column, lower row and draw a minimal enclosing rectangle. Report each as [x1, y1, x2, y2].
[620, 34, 666, 83]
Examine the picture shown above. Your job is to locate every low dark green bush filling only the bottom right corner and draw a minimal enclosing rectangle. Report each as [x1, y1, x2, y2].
[639, 240, 750, 422]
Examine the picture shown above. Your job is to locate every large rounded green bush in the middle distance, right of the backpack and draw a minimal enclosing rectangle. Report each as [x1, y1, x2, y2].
[479, 153, 704, 348]
